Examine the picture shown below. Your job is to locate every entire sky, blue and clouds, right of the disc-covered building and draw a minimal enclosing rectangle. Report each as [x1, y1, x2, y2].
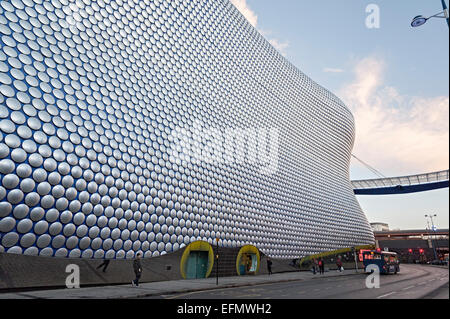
[231, 0, 449, 229]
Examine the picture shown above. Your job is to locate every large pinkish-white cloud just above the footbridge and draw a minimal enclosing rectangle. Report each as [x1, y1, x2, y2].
[339, 56, 449, 175]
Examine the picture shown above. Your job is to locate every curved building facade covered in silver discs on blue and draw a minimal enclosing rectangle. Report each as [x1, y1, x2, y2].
[0, 0, 374, 259]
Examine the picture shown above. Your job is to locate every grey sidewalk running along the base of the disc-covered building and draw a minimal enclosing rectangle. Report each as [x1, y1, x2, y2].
[0, 269, 362, 299]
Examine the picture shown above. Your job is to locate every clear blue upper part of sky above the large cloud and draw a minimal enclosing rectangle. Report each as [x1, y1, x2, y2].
[247, 0, 449, 97]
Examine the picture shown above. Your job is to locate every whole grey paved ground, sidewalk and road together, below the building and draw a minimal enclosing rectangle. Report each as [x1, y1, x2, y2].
[0, 265, 448, 299]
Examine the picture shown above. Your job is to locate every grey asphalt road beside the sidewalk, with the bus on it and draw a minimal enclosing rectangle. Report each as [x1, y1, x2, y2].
[151, 265, 449, 299]
